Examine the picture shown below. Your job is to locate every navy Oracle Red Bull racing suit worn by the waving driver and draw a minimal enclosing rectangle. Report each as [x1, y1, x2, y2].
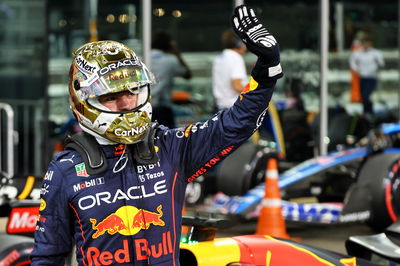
[31, 78, 275, 265]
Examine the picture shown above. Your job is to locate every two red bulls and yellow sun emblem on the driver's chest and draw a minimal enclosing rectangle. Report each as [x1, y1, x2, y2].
[90, 205, 165, 238]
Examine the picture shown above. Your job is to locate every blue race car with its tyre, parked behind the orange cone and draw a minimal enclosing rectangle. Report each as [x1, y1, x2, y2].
[205, 124, 400, 231]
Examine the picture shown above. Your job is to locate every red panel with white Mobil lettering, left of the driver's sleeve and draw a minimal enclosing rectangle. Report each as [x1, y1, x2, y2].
[7, 207, 39, 234]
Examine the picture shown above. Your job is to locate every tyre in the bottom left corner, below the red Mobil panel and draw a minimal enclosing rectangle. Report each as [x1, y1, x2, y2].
[0, 234, 33, 265]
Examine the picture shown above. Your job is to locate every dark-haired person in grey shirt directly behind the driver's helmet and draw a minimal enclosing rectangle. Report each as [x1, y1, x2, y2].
[151, 31, 192, 128]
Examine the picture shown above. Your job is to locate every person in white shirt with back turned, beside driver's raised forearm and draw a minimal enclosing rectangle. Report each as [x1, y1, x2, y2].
[212, 29, 247, 110]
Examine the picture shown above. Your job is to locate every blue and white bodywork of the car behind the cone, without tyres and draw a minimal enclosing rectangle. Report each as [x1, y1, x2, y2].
[206, 124, 400, 223]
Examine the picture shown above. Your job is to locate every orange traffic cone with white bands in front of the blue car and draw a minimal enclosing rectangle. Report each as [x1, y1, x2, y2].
[256, 158, 290, 239]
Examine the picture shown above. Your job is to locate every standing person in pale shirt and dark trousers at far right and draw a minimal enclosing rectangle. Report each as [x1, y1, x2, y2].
[350, 36, 385, 116]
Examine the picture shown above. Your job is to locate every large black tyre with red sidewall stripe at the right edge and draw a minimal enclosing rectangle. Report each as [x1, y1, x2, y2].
[357, 153, 400, 232]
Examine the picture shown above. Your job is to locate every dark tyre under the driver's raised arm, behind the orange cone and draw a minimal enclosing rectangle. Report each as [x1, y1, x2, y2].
[216, 142, 272, 196]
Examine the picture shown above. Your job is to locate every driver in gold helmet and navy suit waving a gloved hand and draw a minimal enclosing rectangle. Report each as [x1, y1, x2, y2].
[31, 5, 283, 265]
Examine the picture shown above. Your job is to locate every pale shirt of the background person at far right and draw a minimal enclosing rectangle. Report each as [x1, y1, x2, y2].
[350, 48, 385, 78]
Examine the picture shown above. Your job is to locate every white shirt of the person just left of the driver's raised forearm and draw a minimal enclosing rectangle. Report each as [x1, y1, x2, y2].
[212, 49, 247, 109]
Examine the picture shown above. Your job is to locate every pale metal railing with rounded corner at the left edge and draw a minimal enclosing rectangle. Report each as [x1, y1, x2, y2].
[0, 103, 15, 178]
